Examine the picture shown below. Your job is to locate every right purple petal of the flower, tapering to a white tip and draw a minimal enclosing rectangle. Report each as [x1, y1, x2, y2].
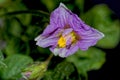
[79, 28, 104, 50]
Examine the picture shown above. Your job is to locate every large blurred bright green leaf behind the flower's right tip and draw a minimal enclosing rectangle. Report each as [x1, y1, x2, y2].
[81, 4, 120, 48]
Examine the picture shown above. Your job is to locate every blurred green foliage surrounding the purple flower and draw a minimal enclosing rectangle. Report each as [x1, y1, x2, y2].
[0, 0, 120, 80]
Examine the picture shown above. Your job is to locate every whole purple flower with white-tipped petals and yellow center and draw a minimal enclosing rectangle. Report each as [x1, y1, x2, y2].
[35, 3, 104, 57]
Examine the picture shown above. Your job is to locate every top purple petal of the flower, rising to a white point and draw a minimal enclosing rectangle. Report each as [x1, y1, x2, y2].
[50, 3, 90, 31]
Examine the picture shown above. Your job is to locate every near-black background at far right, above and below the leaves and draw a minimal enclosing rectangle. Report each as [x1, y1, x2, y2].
[85, 0, 120, 80]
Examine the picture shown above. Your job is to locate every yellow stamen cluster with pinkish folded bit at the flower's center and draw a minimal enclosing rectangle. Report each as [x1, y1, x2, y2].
[57, 32, 76, 48]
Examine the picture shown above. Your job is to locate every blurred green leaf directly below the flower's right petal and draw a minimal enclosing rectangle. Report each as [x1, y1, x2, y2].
[67, 48, 105, 75]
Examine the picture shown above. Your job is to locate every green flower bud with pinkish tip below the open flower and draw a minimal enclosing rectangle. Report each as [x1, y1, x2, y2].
[22, 61, 48, 80]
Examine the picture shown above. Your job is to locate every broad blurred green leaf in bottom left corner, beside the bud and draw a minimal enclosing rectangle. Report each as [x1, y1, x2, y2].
[0, 54, 33, 80]
